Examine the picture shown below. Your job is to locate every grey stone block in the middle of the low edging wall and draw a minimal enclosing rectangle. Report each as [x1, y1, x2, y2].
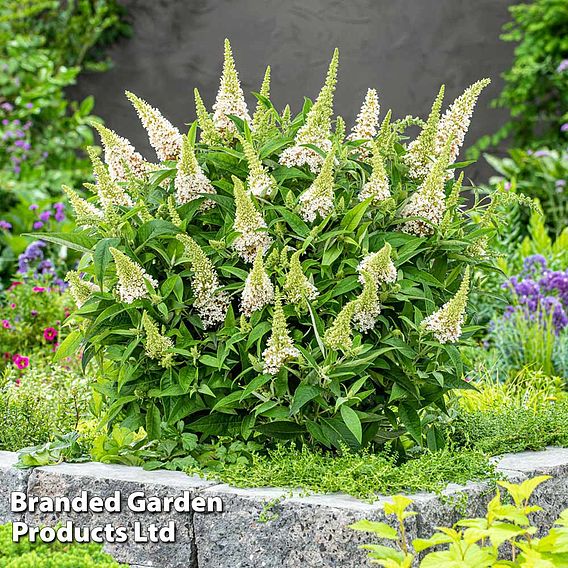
[193, 485, 416, 568]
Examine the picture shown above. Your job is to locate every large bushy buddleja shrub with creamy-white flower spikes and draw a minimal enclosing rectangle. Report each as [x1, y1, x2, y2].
[45, 42, 502, 448]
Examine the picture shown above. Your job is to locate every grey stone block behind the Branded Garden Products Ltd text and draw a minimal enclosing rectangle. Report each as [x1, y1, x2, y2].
[25, 463, 216, 568]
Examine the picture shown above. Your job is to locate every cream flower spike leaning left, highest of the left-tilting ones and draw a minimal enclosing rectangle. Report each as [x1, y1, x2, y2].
[126, 91, 182, 162]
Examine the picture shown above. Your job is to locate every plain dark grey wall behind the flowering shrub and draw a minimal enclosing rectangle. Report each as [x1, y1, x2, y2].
[74, 0, 513, 179]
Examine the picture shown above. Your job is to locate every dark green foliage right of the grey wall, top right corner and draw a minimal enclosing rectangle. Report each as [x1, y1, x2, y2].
[477, 0, 568, 149]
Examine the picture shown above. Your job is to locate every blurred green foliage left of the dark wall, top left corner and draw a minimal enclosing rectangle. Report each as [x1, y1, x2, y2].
[0, 0, 129, 279]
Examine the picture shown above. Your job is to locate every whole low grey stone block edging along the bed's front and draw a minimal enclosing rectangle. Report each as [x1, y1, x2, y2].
[0, 448, 568, 568]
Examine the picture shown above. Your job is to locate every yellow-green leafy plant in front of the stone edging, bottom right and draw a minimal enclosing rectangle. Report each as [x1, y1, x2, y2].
[351, 475, 568, 568]
